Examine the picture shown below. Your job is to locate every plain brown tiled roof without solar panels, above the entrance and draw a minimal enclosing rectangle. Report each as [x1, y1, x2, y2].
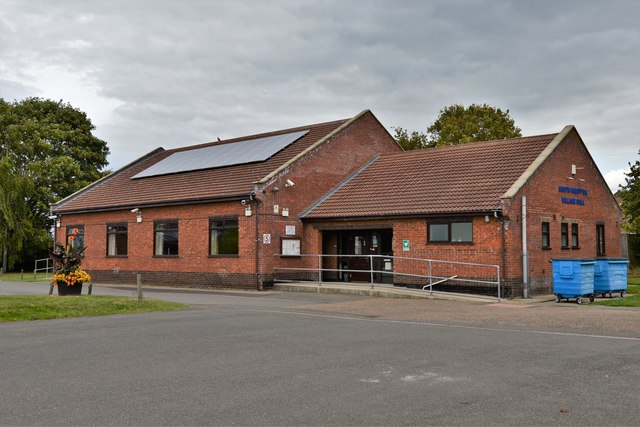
[304, 134, 558, 219]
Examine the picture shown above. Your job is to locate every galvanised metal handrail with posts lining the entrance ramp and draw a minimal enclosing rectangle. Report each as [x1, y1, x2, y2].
[274, 254, 501, 301]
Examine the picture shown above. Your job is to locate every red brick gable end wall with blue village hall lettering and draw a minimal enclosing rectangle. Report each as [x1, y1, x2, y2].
[505, 131, 621, 293]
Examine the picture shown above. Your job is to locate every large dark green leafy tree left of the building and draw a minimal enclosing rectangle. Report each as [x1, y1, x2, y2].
[0, 98, 109, 270]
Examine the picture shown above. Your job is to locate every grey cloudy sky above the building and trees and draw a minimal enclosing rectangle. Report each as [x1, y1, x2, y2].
[0, 0, 640, 189]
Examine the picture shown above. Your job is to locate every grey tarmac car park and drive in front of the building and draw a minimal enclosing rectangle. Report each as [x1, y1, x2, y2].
[0, 282, 640, 425]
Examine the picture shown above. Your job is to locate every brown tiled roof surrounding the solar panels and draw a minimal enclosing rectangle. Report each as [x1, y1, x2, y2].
[53, 116, 350, 213]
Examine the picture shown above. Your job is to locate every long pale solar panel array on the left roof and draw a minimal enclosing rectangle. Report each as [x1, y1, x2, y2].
[133, 130, 309, 178]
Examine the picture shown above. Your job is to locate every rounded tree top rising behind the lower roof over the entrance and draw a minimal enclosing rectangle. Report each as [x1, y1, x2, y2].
[427, 104, 522, 147]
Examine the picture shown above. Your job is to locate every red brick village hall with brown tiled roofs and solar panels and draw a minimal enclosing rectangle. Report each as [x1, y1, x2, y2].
[52, 111, 621, 295]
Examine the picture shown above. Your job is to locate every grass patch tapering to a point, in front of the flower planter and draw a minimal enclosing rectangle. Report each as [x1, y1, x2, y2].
[0, 296, 188, 322]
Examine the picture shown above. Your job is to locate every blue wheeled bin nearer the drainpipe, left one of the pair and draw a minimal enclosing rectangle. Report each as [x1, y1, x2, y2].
[551, 258, 595, 304]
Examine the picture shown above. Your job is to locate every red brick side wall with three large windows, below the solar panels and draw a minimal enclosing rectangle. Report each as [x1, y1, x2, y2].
[56, 201, 255, 287]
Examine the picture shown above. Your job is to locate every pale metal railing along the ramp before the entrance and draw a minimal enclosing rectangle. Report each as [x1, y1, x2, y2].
[274, 254, 501, 301]
